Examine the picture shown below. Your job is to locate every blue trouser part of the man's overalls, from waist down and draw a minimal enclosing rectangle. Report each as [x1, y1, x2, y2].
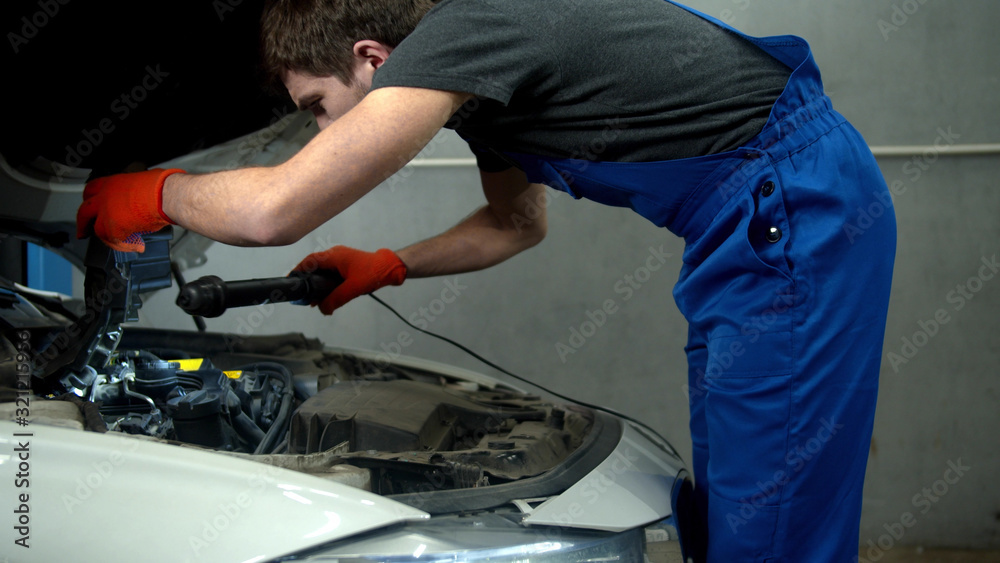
[675, 117, 895, 562]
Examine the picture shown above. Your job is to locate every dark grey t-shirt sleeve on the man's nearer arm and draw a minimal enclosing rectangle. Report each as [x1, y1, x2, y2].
[372, 0, 555, 105]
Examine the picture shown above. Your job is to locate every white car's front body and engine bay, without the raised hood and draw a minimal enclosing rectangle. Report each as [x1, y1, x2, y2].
[0, 214, 690, 562]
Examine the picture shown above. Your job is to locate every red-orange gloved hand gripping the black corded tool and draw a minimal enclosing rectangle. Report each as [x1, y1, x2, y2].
[293, 246, 406, 315]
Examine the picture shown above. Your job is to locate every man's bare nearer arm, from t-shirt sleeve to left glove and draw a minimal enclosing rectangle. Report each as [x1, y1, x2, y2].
[162, 88, 469, 246]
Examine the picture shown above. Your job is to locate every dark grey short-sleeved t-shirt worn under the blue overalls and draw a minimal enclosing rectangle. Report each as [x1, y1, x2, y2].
[372, 0, 791, 170]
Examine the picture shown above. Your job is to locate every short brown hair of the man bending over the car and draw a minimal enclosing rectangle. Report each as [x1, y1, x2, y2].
[261, 0, 434, 85]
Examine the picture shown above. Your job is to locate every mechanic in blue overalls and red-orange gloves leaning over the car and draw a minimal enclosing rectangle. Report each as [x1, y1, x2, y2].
[78, 0, 896, 563]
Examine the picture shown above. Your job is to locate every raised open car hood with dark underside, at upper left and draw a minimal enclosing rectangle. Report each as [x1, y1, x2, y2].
[0, 0, 317, 269]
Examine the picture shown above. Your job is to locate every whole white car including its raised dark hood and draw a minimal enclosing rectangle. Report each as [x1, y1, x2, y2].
[0, 0, 695, 563]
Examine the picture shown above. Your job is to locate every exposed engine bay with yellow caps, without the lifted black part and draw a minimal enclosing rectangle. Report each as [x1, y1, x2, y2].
[54, 329, 594, 495]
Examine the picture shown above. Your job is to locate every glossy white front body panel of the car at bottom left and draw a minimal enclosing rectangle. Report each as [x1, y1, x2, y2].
[0, 421, 429, 563]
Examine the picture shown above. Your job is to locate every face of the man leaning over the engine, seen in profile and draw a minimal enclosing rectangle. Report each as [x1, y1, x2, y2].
[282, 70, 370, 129]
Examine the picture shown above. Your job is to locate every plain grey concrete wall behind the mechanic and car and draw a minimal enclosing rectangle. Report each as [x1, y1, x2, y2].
[135, 0, 1000, 560]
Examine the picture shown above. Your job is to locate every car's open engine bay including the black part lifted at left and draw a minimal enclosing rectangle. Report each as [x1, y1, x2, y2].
[0, 229, 596, 511]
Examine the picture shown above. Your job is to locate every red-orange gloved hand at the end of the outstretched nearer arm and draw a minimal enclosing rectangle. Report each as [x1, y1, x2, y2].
[76, 168, 184, 252]
